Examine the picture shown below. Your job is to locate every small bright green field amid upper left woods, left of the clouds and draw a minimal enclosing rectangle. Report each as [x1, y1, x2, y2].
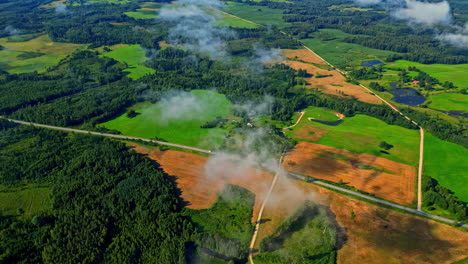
[102, 45, 156, 80]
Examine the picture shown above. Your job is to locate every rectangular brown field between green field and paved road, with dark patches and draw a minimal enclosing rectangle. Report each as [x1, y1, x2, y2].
[283, 142, 416, 205]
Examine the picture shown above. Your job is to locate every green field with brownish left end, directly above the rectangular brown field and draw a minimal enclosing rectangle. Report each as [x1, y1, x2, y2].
[286, 111, 419, 166]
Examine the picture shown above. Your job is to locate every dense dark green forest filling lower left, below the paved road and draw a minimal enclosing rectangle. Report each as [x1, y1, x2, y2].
[0, 120, 194, 263]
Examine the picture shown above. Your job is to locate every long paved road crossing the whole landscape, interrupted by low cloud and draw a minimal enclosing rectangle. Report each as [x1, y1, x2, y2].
[0, 116, 468, 228]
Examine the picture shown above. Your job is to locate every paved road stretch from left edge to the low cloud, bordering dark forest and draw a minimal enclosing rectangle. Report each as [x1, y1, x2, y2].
[0, 116, 211, 154]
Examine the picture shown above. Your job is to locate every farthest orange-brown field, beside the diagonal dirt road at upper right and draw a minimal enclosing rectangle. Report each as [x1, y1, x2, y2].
[283, 49, 382, 104]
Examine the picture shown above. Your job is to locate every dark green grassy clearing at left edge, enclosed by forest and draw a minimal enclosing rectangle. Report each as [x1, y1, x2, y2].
[0, 185, 52, 217]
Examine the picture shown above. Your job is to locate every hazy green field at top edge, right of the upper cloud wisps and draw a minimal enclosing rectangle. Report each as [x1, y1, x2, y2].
[225, 2, 289, 27]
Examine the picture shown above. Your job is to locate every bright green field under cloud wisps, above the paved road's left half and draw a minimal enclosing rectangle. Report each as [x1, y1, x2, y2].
[102, 90, 231, 149]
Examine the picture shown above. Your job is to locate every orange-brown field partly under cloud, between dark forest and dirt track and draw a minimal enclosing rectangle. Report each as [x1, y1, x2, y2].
[133, 144, 273, 222]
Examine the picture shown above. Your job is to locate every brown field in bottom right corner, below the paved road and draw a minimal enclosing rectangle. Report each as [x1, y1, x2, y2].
[256, 179, 468, 264]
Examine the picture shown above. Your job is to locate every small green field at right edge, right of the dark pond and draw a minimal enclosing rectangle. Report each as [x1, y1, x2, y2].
[428, 93, 468, 112]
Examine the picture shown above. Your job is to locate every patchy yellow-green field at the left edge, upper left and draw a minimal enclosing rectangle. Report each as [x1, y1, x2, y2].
[0, 35, 86, 73]
